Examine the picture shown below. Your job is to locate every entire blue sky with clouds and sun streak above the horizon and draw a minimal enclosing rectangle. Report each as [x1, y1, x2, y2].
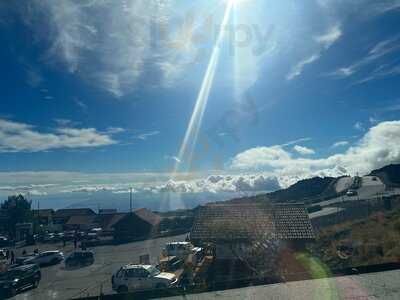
[0, 0, 400, 206]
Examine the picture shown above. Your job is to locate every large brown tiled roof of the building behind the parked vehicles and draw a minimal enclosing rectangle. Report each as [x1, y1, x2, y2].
[190, 204, 315, 241]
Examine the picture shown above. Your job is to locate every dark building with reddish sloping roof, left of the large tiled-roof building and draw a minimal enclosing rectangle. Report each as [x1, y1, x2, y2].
[112, 208, 161, 241]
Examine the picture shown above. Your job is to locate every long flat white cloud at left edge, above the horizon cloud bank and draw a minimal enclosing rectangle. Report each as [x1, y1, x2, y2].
[0, 119, 116, 152]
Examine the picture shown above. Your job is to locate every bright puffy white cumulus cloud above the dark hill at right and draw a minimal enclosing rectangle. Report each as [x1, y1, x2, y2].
[230, 121, 400, 186]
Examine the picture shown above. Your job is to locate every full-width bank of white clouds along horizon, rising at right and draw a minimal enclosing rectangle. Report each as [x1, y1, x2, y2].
[0, 121, 400, 196]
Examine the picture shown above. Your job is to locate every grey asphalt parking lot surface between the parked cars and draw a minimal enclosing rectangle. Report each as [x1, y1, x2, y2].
[11, 235, 186, 300]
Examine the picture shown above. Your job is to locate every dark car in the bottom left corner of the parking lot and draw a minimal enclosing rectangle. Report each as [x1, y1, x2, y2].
[0, 264, 42, 297]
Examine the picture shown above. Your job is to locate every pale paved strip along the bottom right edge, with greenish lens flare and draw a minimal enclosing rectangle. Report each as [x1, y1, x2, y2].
[164, 270, 400, 300]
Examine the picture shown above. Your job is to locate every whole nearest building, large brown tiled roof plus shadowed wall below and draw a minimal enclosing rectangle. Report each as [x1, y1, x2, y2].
[190, 204, 315, 260]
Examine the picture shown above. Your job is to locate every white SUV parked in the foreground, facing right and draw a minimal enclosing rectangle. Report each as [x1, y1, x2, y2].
[111, 265, 178, 293]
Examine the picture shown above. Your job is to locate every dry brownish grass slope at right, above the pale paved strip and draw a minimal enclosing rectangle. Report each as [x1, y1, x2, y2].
[310, 209, 400, 268]
